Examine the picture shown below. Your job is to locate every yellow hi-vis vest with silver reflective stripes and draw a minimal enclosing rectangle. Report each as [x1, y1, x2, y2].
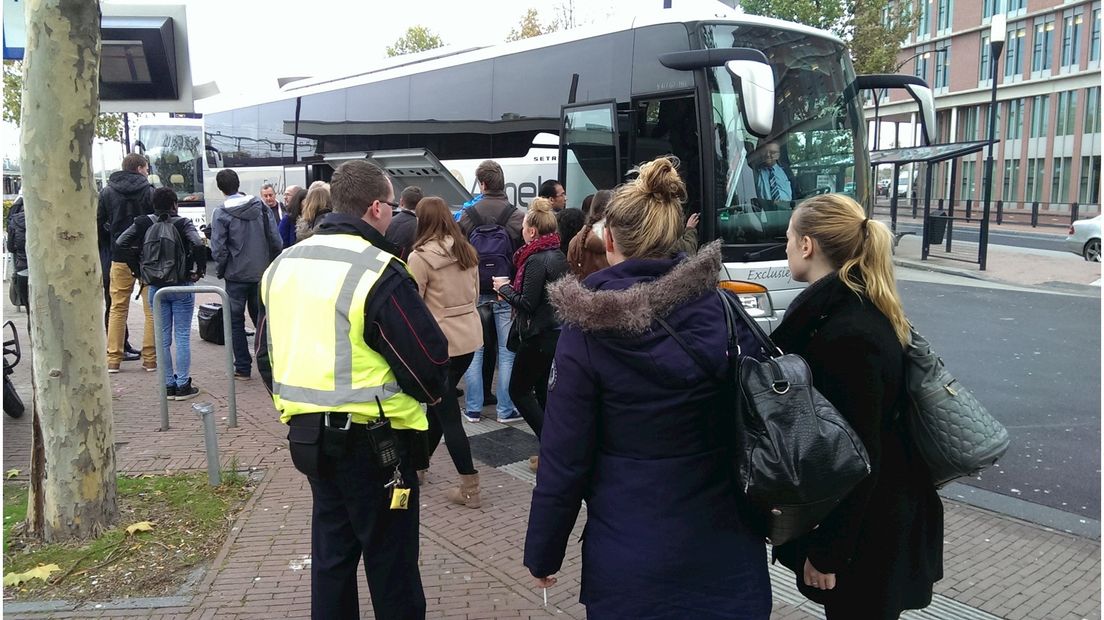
[261, 229, 428, 430]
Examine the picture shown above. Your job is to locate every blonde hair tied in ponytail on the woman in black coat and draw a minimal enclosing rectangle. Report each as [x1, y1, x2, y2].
[793, 194, 910, 346]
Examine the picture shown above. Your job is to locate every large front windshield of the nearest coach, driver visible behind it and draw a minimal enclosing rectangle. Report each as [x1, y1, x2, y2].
[702, 24, 869, 261]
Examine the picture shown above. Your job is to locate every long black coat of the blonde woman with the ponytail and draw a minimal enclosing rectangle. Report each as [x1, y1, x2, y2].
[772, 275, 943, 618]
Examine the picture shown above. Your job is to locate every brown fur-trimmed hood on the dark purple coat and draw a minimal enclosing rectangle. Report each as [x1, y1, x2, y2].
[549, 240, 721, 336]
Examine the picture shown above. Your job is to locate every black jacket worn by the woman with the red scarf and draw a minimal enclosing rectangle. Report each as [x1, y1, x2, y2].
[498, 248, 567, 341]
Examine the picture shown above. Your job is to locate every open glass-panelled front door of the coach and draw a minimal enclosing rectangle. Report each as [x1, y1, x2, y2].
[558, 99, 620, 204]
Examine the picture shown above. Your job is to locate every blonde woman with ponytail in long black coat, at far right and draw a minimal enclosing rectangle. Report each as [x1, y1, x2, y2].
[771, 194, 943, 620]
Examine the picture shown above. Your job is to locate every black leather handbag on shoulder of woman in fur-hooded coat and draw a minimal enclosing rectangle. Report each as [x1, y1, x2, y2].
[660, 291, 870, 545]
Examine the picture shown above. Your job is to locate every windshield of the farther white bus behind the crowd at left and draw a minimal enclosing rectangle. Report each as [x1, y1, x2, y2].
[138, 120, 203, 202]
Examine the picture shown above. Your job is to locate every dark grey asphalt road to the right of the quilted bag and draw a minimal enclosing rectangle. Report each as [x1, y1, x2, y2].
[900, 275, 1101, 520]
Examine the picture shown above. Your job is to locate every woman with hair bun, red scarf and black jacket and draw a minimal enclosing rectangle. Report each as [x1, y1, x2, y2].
[493, 199, 567, 438]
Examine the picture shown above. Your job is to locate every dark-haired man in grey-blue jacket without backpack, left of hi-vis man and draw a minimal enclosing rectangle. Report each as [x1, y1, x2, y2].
[211, 168, 284, 380]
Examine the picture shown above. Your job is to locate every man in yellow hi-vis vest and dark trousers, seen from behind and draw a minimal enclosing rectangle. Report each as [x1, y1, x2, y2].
[261, 160, 448, 619]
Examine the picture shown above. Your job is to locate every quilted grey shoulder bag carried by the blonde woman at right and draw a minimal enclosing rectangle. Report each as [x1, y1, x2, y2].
[904, 329, 1008, 487]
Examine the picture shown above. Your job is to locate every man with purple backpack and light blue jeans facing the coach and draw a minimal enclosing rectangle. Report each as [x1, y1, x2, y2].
[459, 160, 526, 421]
